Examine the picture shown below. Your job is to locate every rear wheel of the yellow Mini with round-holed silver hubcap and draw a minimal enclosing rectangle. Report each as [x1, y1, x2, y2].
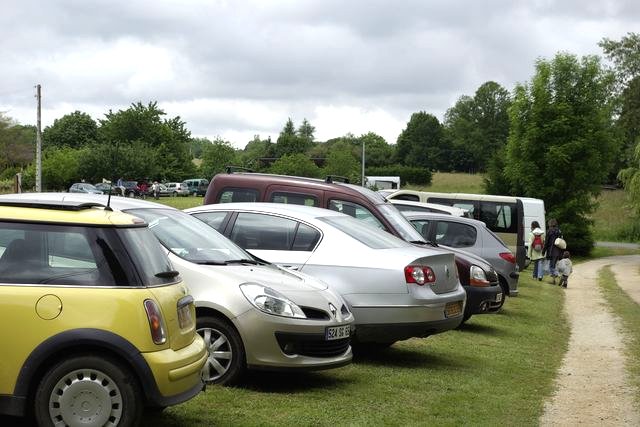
[34, 355, 144, 427]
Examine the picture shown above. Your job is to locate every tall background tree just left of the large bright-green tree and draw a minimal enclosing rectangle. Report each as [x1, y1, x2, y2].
[445, 81, 511, 171]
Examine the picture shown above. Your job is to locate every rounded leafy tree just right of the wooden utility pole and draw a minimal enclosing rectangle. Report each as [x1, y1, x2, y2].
[42, 111, 98, 148]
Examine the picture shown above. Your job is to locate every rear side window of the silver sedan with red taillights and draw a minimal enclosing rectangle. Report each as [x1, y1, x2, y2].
[230, 212, 320, 251]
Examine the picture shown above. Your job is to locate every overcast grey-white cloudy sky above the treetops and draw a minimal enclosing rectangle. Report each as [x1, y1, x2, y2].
[0, 0, 640, 147]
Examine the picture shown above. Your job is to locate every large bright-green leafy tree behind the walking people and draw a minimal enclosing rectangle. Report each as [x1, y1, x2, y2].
[504, 53, 618, 254]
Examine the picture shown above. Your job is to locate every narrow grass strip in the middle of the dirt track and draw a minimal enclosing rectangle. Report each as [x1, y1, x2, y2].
[598, 266, 640, 409]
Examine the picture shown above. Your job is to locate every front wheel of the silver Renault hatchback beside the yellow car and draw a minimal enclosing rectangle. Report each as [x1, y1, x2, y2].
[196, 316, 246, 384]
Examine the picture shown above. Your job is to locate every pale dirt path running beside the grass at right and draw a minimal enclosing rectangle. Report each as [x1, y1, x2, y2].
[540, 255, 640, 426]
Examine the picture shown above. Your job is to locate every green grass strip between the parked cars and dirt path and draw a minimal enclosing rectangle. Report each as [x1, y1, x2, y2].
[147, 271, 569, 426]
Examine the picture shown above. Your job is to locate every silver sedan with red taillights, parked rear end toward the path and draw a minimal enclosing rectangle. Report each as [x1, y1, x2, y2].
[186, 203, 465, 345]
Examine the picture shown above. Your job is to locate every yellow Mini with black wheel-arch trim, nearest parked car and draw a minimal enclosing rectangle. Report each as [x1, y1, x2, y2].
[0, 200, 207, 426]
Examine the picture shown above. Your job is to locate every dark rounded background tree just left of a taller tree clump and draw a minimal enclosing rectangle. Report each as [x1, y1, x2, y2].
[396, 111, 451, 171]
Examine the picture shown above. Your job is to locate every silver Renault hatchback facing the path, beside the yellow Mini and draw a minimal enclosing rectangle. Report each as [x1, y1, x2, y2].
[11, 193, 354, 384]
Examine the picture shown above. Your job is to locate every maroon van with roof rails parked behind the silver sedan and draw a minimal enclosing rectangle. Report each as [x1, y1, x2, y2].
[205, 172, 508, 320]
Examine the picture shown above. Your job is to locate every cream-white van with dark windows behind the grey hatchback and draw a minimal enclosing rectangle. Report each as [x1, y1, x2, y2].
[387, 190, 545, 270]
